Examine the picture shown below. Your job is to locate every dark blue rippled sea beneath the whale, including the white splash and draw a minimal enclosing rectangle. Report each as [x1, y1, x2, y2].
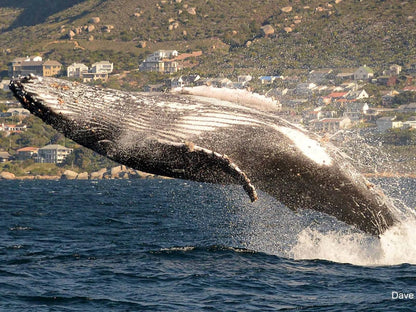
[0, 179, 416, 311]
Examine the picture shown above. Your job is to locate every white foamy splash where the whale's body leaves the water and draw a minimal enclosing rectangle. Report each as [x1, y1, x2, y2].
[291, 220, 416, 266]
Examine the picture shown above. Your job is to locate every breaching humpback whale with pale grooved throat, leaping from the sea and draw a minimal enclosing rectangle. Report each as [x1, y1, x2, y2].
[9, 75, 397, 236]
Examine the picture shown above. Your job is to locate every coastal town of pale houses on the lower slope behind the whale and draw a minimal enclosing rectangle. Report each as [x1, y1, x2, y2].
[0, 50, 416, 178]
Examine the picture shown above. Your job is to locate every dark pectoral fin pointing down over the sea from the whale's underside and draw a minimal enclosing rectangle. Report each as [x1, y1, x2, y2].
[134, 141, 257, 201]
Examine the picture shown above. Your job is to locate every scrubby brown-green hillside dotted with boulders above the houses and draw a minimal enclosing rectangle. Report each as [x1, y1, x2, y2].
[0, 0, 416, 76]
